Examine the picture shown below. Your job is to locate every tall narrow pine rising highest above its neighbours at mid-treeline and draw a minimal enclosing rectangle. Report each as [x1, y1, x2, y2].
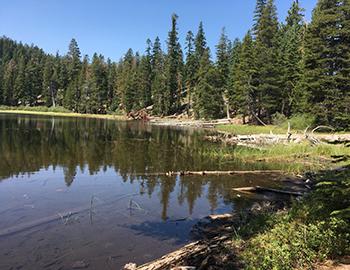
[164, 14, 183, 115]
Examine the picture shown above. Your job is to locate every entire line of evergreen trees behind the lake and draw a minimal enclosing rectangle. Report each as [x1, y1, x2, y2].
[0, 0, 350, 129]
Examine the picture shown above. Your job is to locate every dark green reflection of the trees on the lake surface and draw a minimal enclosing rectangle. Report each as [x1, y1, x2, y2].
[0, 115, 270, 219]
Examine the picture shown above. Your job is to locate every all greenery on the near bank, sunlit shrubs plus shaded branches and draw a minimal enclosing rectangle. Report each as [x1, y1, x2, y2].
[237, 166, 350, 270]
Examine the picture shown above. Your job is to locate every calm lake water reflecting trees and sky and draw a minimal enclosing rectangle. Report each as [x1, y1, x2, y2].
[0, 114, 284, 270]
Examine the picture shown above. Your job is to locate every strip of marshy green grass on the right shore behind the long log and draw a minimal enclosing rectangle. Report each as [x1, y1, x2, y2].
[204, 142, 350, 173]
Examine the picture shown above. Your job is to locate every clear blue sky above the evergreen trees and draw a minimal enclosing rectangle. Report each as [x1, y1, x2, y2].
[0, 0, 317, 60]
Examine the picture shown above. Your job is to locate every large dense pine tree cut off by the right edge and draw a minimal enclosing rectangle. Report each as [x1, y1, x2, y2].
[303, 0, 350, 129]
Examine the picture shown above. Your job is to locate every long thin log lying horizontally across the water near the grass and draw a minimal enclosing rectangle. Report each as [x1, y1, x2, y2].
[136, 170, 283, 176]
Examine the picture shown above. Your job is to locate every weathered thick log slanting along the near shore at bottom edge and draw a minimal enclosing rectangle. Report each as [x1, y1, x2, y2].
[124, 235, 231, 270]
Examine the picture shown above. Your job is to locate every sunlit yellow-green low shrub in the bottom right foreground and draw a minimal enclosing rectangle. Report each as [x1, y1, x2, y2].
[243, 218, 349, 270]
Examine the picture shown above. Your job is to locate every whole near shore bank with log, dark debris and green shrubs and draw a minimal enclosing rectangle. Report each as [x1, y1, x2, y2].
[124, 165, 350, 270]
